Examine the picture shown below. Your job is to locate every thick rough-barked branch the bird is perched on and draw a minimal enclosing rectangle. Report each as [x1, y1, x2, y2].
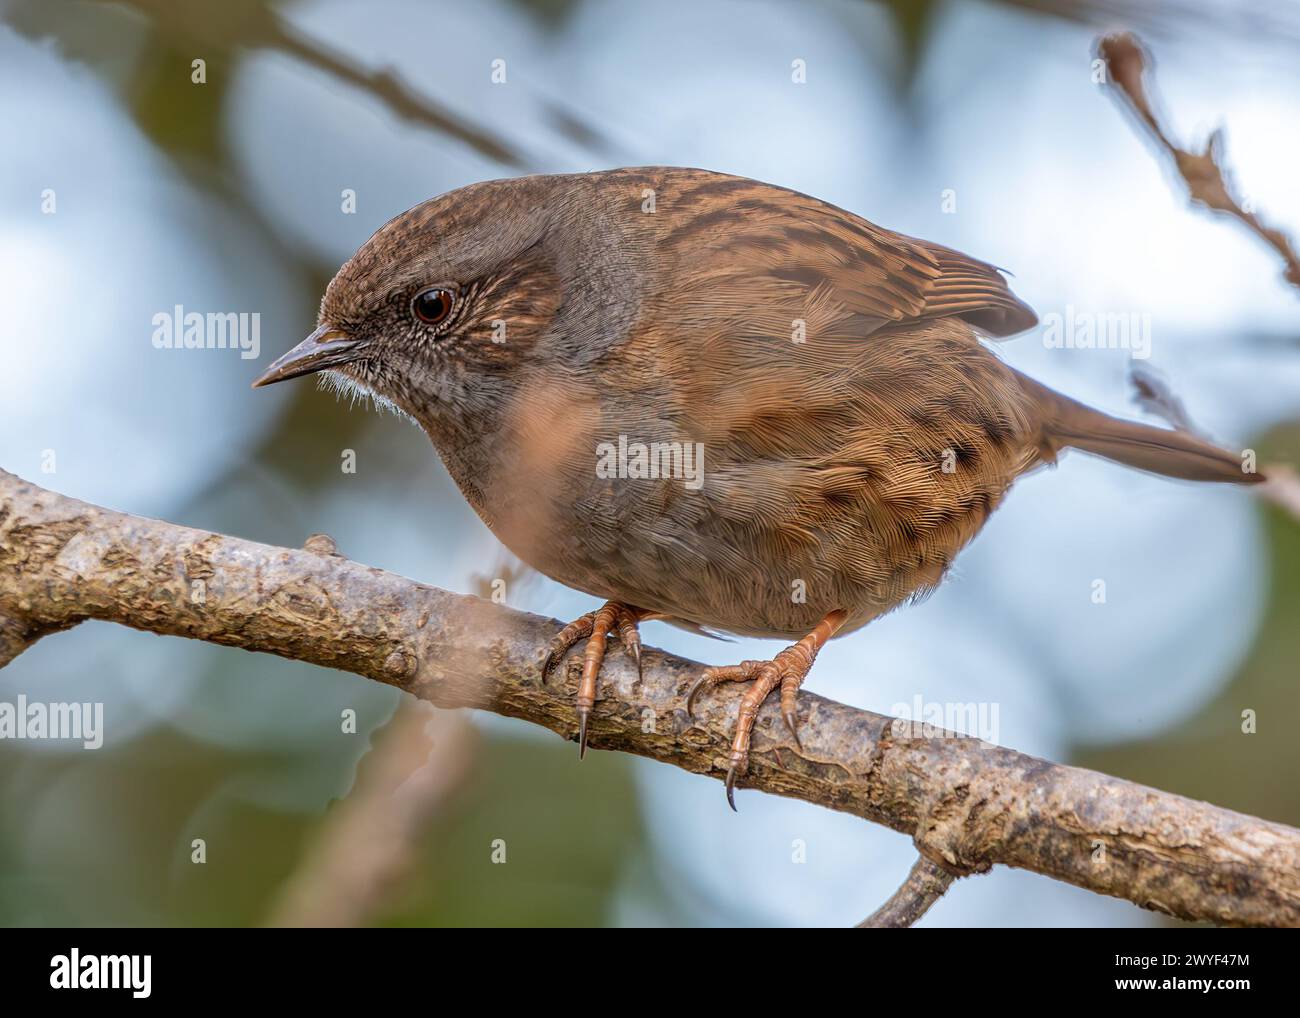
[0, 471, 1300, 926]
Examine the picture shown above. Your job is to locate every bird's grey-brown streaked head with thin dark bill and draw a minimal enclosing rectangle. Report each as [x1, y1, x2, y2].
[254, 177, 605, 426]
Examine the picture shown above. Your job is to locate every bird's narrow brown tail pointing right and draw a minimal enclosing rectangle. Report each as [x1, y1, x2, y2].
[1022, 376, 1265, 484]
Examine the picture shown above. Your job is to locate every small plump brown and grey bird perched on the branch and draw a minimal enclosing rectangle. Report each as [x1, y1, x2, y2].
[255, 168, 1262, 809]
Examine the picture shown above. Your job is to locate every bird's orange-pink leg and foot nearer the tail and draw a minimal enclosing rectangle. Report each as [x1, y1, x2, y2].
[686, 608, 846, 810]
